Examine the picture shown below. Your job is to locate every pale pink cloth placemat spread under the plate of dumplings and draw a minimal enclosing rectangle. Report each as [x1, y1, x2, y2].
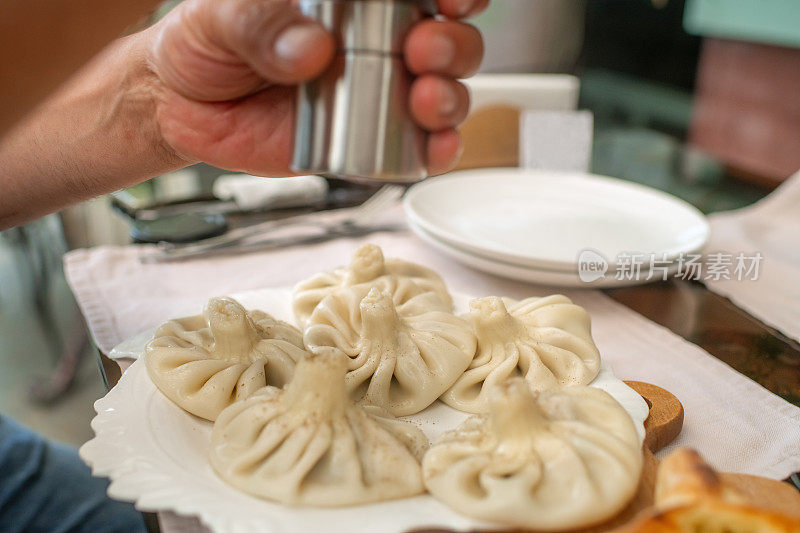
[65, 224, 800, 479]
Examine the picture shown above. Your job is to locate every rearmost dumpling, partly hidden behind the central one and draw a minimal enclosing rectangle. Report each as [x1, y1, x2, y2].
[293, 244, 453, 327]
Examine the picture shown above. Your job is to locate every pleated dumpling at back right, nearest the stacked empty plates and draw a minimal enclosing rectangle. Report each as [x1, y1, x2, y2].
[442, 295, 600, 413]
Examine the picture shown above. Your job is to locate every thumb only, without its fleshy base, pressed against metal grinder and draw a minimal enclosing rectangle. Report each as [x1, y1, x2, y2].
[209, 0, 335, 84]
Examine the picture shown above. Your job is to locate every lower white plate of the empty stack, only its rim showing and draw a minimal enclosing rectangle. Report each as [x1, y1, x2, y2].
[408, 221, 680, 289]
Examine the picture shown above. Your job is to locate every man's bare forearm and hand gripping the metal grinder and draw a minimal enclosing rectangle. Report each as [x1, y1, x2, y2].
[0, 0, 488, 229]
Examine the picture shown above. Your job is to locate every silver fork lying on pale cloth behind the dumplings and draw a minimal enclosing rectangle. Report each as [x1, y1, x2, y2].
[149, 185, 405, 259]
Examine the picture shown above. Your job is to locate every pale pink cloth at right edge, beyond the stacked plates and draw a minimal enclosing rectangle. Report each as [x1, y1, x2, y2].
[704, 172, 800, 340]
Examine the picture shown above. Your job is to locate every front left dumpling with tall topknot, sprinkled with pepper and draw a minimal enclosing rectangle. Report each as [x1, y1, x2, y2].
[211, 356, 428, 507]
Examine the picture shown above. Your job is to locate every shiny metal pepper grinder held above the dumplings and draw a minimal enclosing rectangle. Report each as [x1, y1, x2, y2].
[292, 0, 436, 183]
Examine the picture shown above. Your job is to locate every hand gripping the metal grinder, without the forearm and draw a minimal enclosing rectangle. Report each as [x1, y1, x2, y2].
[143, 0, 489, 176]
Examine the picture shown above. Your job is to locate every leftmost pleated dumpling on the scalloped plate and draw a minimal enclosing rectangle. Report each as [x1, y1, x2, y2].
[145, 298, 306, 421]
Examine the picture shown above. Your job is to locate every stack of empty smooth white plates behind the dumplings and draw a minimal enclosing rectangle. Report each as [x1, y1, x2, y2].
[405, 168, 709, 287]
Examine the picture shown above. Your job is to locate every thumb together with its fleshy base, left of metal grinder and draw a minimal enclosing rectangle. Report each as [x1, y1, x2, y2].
[152, 0, 335, 101]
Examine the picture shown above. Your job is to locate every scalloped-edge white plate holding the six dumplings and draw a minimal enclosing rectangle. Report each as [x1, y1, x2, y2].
[80, 290, 648, 533]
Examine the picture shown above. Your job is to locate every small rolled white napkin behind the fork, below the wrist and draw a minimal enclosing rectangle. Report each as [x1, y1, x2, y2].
[214, 174, 328, 211]
